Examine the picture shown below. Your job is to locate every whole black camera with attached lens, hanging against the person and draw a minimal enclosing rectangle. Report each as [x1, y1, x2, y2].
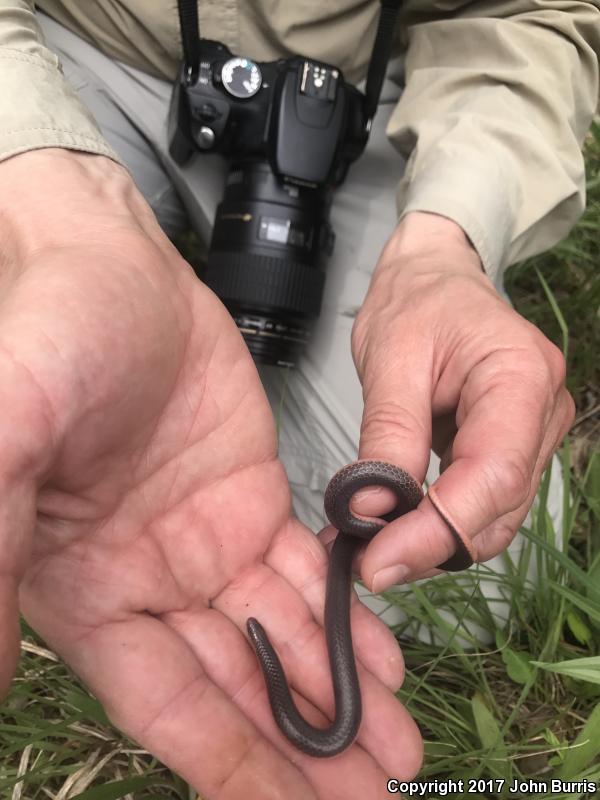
[168, 0, 398, 367]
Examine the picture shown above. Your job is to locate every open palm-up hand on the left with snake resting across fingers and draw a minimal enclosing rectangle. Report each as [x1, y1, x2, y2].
[0, 150, 421, 800]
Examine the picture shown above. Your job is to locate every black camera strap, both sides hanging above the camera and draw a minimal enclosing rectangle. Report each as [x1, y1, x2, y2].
[177, 0, 402, 119]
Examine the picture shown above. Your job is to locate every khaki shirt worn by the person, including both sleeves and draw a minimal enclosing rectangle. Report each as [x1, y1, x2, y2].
[0, 0, 600, 278]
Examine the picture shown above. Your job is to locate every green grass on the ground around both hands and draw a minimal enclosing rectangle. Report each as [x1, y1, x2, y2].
[0, 126, 600, 800]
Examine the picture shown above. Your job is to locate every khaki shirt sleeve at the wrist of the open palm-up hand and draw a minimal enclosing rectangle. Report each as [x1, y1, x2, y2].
[0, 0, 119, 161]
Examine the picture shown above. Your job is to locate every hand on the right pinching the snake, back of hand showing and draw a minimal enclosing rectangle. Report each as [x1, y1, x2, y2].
[352, 213, 574, 592]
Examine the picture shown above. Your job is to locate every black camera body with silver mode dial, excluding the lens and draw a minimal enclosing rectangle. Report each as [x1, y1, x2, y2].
[169, 39, 368, 187]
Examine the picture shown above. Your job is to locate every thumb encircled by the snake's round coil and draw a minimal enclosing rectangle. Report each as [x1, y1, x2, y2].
[351, 342, 432, 516]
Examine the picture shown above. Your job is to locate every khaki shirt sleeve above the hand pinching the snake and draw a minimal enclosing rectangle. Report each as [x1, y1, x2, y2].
[387, 0, 600, 280]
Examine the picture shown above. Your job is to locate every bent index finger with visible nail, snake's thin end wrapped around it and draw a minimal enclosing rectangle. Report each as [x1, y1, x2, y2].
[362, 356, 554, 592]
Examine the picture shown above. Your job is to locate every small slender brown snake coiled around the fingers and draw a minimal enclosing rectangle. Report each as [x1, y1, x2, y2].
[246, 460, 472, 758]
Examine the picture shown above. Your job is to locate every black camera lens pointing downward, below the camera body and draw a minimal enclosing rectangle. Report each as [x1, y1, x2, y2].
[201, 160, 333, 366]
